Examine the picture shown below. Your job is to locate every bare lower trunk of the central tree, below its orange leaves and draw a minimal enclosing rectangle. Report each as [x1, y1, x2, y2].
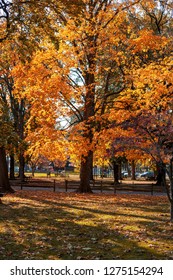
[77, 151, 93, 193]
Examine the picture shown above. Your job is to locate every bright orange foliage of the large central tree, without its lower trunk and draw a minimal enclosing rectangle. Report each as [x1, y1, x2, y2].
[3, 0, 172, 168]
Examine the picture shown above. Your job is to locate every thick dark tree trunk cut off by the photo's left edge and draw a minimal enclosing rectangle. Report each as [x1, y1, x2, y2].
[0, 147, 14, 192]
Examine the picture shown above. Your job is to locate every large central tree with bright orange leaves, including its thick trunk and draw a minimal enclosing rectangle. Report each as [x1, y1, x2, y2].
[10, 0, 171, 201]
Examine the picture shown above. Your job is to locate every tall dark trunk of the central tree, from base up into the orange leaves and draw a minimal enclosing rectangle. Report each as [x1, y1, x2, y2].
[76, 32, 97, 193]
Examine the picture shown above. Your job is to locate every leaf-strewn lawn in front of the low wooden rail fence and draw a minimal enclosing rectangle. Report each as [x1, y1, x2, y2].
[0, 191, 173, 260]
